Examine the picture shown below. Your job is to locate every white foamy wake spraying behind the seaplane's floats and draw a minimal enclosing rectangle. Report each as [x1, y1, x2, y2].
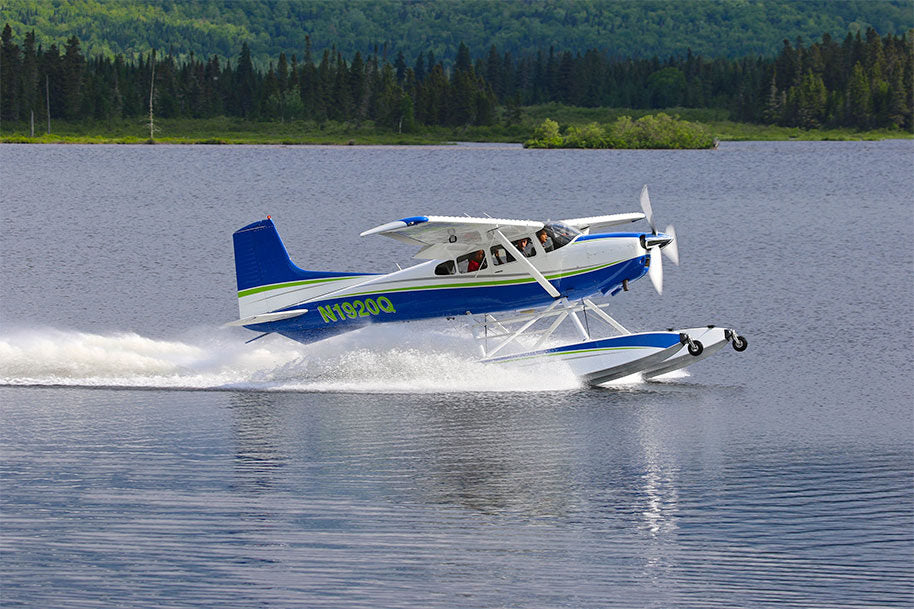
[0, 326, 580, 393]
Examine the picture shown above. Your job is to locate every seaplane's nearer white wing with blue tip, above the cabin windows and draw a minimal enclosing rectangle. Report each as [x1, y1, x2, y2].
[361, 216, 543, 260]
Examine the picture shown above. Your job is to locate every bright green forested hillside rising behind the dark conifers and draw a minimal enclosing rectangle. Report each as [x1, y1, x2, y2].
[0, 0, 914, 65]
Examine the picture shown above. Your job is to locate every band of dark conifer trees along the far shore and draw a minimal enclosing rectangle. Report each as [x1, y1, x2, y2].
[0, 25, 914, 132]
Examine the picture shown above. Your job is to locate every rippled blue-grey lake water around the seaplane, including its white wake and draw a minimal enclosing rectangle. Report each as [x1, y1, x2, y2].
[0, 141, 914, 608]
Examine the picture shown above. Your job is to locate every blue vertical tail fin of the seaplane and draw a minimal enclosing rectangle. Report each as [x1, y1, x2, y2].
[232, 217, 360, 292]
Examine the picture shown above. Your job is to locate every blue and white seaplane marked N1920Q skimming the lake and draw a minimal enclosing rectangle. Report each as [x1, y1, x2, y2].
[227, 186, 748, 385]
